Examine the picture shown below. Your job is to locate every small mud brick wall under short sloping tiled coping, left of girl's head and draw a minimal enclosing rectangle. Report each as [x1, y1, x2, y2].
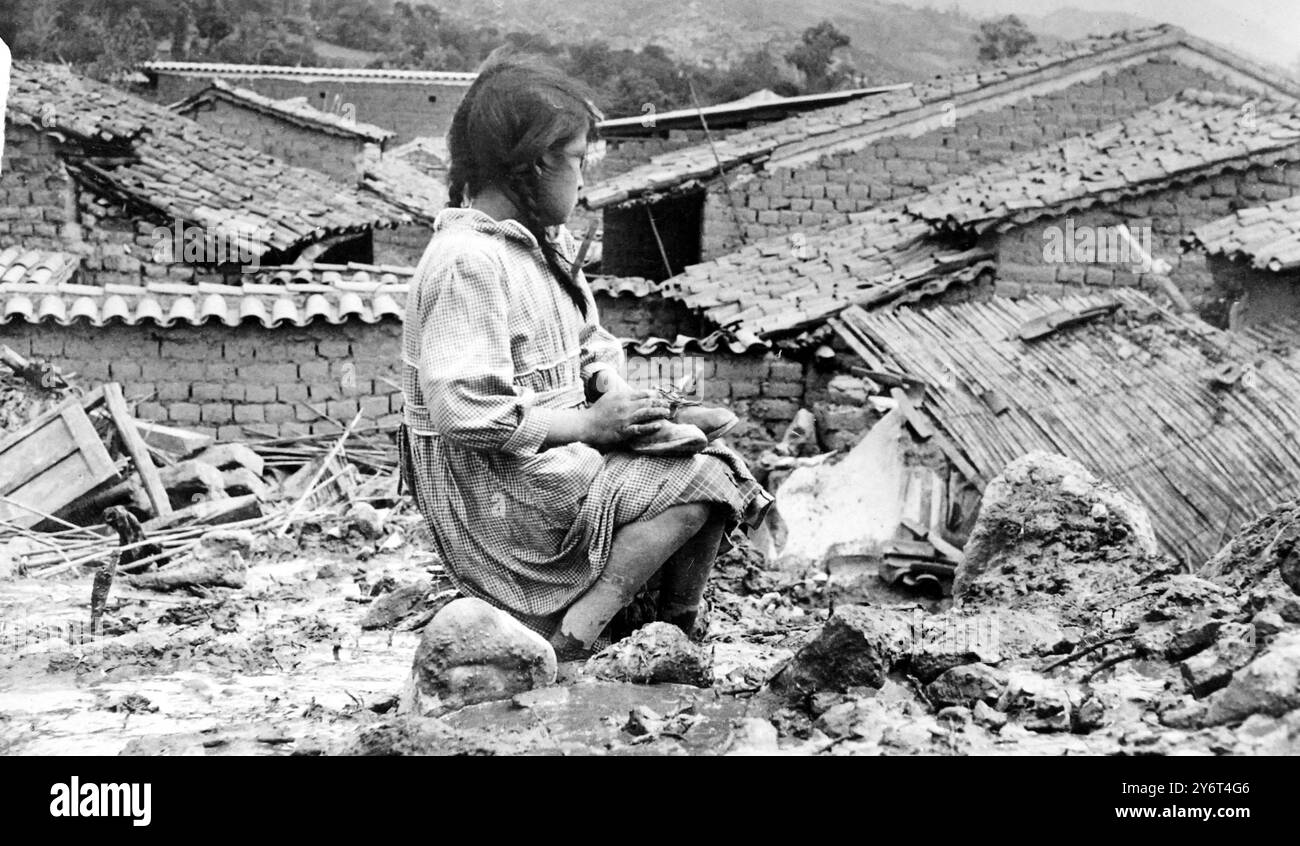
[187, 100, 365, 185]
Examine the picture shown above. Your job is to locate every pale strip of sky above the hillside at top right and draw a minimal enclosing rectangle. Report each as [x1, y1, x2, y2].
[915, 0, 1300, 66]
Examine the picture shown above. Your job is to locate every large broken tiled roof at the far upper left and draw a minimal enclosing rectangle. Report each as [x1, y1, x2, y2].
[8, 62, 408, 255]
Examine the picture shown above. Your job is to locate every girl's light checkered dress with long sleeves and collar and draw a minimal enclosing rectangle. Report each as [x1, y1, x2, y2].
[402, 208, 772, 634]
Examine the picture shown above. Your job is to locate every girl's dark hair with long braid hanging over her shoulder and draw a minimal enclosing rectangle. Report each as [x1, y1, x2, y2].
[447, 47, 601, 317]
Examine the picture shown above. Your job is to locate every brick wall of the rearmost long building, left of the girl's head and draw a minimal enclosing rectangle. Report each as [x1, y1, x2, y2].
[131, 74, 469, 144]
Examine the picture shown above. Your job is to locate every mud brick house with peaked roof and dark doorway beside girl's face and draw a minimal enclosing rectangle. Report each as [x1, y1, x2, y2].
[585, 26, 1300, 279]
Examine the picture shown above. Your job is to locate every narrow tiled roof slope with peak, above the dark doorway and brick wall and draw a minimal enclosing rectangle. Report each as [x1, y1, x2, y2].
[584, 26, 1300, 208]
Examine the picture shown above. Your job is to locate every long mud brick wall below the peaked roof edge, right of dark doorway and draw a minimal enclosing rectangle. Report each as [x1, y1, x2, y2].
[703, 57, 1247, 259]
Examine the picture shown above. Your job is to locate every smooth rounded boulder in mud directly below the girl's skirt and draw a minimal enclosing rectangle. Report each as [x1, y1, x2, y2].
[403, 598, 556, 715]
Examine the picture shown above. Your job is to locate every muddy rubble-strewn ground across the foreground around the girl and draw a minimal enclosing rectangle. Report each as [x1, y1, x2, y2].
[0, 452, 1300, 755]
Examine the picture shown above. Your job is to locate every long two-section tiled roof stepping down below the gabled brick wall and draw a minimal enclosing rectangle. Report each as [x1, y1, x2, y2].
[663, 85, 1300, 337]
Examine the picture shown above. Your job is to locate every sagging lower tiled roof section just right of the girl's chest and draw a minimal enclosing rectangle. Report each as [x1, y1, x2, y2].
[662, 203, 991, 337]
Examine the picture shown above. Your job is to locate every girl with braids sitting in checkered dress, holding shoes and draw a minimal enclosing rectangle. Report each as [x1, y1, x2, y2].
[400, 51, 772, 660]
